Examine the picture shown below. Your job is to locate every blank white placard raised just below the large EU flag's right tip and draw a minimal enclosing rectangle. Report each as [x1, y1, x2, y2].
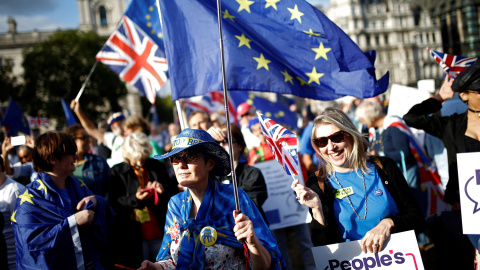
[388, 84, 430, 117]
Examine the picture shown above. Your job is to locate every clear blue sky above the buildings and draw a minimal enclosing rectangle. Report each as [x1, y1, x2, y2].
[0, 0, 330, 33]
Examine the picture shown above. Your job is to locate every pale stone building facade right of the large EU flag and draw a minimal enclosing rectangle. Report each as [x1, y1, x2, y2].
[326, 0, 442, 86]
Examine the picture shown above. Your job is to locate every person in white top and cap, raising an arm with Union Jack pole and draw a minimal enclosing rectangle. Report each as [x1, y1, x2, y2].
[70, 100, 125, 167]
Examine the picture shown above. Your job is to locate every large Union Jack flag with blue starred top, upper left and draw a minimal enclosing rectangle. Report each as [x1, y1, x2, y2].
[97, 0, 168, 104]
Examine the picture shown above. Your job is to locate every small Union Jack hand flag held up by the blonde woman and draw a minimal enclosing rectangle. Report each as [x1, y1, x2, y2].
[257, 112, 300, 175]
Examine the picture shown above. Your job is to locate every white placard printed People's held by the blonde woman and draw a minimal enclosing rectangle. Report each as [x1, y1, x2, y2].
[312, 231, 424, 270]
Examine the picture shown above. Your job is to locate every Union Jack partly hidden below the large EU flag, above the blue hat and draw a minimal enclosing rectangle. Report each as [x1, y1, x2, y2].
[182, 91, 237, 123]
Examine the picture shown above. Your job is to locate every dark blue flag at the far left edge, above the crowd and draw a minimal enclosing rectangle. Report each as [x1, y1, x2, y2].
[2, 98, 30, 137]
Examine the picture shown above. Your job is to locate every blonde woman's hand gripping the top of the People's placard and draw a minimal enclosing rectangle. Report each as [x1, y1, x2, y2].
[360, 218, 395, 253]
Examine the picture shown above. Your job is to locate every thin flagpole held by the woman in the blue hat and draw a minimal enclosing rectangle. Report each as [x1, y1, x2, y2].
[217, 0, 241, 213]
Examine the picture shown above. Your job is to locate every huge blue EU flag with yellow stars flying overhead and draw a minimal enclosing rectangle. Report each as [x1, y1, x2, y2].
[160, 0, 388, 100]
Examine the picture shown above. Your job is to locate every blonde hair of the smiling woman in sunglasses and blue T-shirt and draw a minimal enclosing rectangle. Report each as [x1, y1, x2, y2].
[310, 108, 369, 176]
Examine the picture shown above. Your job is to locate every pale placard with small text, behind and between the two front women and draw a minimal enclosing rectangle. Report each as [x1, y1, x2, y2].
[253, 160, 311, 230]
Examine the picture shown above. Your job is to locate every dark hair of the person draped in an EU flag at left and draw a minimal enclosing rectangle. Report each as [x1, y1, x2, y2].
[32, 131, 77, 172]
